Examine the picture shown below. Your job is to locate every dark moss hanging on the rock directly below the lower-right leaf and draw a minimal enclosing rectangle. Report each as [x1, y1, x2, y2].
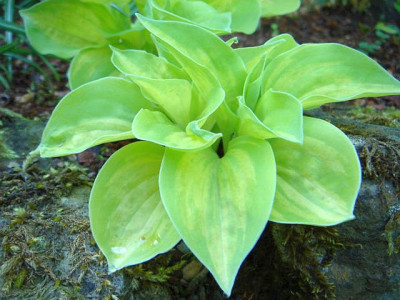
[271, 224, 344, 299]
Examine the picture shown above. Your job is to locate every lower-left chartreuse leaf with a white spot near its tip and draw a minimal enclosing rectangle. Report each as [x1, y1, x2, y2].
[89, 142, 180, 272]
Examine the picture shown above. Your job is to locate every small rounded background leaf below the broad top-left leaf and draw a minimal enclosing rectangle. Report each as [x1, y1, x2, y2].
[68, 46, 121, 89]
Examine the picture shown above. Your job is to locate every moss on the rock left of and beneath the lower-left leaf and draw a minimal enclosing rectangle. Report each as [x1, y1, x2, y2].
[0, 159, 191, 299]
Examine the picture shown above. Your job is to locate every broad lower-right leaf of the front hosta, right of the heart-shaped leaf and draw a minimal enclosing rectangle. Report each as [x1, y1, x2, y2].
[270, 117, 361, 226]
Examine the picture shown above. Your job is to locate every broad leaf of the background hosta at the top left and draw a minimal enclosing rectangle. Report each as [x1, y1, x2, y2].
[21, 0, 130, 58]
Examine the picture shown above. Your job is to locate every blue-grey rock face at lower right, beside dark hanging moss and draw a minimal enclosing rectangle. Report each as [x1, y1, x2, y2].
[326, 128, 400, 300]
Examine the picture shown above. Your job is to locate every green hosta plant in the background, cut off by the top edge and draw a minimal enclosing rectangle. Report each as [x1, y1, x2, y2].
[21, 0, 300, 89]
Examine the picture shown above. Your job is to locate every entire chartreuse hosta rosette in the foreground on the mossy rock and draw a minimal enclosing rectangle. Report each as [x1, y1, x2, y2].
[35, 16, 400, 295]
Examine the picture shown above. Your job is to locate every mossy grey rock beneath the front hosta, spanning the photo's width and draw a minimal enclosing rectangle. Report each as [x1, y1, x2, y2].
[0, 107, 400, 300]
